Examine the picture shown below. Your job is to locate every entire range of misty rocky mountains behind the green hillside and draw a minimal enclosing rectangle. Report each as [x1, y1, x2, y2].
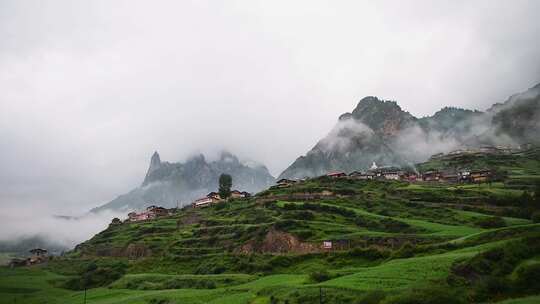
[92, 84, 540, 212]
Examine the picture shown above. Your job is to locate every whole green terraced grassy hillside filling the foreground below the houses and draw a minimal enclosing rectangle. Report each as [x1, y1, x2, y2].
[0, 151, 540, 304]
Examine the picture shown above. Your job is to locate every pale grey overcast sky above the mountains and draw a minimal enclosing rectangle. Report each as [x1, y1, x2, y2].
[0, 0, 540, 214]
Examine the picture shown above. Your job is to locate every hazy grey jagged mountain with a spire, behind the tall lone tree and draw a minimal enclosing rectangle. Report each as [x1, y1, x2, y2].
[92, 152, 274, 212]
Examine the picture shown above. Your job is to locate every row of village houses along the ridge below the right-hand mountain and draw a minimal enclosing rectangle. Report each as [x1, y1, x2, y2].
[272, 163, 492, 189]
